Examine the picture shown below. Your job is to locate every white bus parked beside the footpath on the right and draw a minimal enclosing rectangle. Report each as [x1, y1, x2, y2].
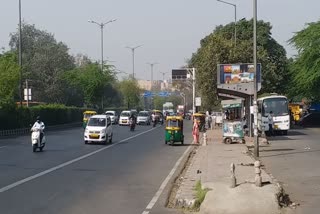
[257, 95, 290, 135]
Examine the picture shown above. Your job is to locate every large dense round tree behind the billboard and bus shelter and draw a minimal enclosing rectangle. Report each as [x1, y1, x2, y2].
[189, 19, 289, 109]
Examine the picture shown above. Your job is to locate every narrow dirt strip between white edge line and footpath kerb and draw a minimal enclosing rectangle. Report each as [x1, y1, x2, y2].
[166, 146, 198, 208]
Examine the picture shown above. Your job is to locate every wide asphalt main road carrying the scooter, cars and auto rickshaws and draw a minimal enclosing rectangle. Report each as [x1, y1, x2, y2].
[0, 123, 191, 214]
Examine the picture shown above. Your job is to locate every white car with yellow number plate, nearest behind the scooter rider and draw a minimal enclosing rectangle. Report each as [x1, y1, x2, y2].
[84, 115, 113, 144]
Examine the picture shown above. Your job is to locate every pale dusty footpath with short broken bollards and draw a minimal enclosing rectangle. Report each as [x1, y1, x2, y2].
[175, 128, 281, 214]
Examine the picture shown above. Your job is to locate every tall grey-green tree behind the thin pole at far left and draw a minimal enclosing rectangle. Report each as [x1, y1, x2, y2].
[9, 23, 75, 103]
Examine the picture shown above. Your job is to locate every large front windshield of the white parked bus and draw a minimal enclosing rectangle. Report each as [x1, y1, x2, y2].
[262, 98, 289, 117]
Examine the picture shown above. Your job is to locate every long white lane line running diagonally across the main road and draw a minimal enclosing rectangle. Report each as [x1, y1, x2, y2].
[0, 126, 160, 193]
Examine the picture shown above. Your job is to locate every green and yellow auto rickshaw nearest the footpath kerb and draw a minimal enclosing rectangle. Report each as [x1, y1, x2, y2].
[165, 116, 184, 145]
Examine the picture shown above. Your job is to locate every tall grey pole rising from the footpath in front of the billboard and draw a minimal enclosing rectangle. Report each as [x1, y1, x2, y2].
[253, 0, 259, 158]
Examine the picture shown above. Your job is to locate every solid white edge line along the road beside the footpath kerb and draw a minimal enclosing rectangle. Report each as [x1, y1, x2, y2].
[142, 146, 192, 214]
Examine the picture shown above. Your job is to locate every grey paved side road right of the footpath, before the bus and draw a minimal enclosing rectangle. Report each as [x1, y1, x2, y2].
[260, 128, 320, 214]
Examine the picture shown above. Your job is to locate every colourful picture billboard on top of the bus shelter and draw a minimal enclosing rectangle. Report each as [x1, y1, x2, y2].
[218, 63, 261, 84]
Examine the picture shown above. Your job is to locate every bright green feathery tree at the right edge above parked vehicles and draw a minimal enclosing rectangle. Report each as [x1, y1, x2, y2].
[289, 21, 320, 101]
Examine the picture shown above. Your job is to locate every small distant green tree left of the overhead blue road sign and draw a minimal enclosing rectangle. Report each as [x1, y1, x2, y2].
[119, 78, 141, 109]
